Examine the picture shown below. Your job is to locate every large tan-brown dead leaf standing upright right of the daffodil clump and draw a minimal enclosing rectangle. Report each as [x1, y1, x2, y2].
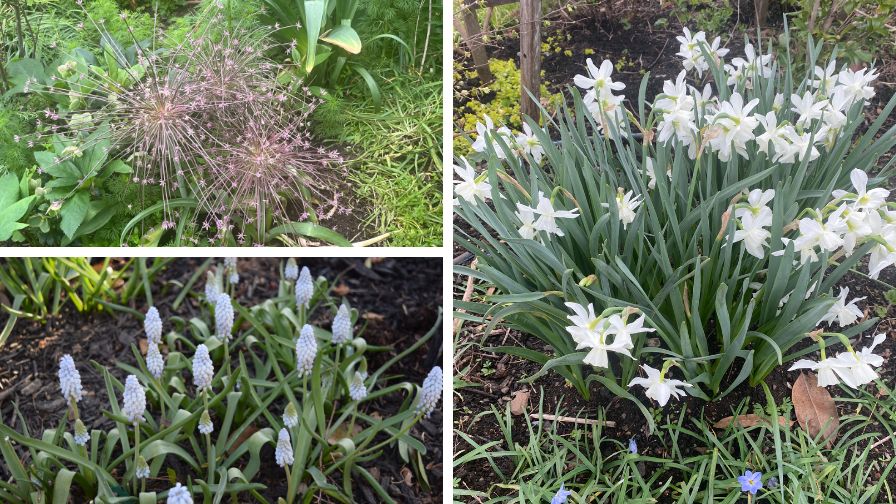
[791, 372, 840, 448]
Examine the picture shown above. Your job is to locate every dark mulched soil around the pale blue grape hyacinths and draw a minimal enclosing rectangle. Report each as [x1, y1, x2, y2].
[0, 258, 443, 503]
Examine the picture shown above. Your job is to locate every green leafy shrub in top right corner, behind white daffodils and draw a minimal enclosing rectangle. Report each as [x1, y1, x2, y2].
[785, 0, 896, 64]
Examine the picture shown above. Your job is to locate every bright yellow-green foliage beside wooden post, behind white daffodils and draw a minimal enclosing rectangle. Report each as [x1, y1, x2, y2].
[454, 59, 563, 155]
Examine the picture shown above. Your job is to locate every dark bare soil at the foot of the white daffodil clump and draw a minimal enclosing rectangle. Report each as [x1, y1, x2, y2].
[453, 269, 896, 502]
